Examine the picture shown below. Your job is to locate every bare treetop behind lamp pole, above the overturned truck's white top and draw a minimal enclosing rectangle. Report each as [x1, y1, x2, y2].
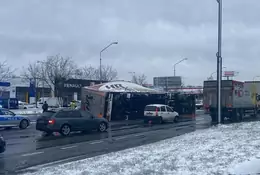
[94, 65, 117, 81]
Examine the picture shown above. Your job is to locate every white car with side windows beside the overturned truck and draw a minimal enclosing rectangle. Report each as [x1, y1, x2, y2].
[144, 104, 179, 123]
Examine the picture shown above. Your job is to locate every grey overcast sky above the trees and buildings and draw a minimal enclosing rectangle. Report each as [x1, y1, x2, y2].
[0, 0, 260, 85]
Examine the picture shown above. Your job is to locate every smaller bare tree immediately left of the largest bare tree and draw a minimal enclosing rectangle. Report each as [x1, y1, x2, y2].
[21, 62, 41, 87]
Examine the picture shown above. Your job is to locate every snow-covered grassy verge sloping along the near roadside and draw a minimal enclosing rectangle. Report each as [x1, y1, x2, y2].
[22, 122, 260, 175]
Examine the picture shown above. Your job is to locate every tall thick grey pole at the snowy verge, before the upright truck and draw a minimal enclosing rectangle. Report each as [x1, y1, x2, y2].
[217, 0, 222, 124]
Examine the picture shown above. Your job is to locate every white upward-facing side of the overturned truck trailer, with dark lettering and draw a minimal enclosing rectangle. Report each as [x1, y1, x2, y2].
[84, 81, 157, 93]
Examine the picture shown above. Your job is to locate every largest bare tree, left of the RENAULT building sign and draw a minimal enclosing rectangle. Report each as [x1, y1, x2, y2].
[40, 54, 78, 95]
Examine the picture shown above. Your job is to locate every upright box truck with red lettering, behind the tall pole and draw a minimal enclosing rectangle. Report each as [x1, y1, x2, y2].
[203, 80, 260, 123]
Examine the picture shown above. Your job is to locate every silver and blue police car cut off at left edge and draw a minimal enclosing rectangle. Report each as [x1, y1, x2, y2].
[0, 108, 30, 129]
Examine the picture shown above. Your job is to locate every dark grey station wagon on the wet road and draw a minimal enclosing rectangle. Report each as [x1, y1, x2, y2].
[36, 109, 108, 136]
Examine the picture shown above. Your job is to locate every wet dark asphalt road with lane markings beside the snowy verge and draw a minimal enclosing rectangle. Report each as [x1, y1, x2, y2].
[0, 112, 211, 174]
